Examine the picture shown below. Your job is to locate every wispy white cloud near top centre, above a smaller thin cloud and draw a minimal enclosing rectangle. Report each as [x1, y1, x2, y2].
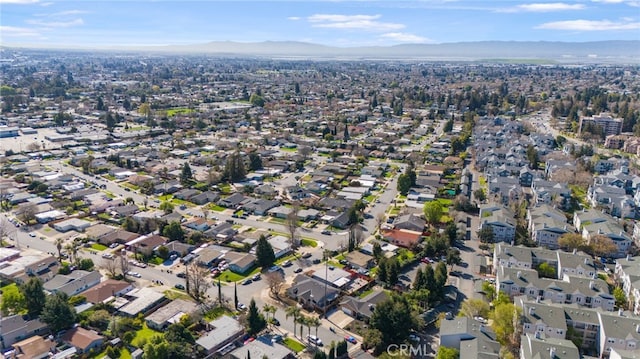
[307, 14, 405, 32]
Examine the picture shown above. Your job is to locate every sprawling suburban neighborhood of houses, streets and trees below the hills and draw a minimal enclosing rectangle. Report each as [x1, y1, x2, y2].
[0, 49, 640, 359]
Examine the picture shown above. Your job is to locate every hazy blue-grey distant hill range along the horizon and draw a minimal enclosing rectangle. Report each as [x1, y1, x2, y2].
[131, 41, 640, 63]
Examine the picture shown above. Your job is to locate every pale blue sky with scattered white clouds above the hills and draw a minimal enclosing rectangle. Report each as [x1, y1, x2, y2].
[0, 0, 640, 47]
